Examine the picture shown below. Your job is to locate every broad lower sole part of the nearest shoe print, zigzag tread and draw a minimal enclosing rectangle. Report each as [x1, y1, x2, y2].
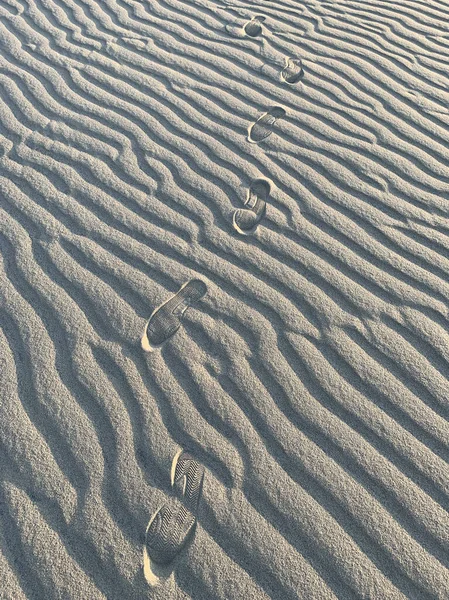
[144, 498, 196, 568]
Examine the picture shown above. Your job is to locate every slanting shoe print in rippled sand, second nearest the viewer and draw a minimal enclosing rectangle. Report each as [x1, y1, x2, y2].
[141, 279, 207, 352]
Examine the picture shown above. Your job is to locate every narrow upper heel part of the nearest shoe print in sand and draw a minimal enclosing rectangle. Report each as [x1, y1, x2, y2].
[171, 449, 204, 514]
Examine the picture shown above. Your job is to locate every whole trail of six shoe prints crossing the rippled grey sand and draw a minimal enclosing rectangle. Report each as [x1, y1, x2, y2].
[141, 16, 304, 585]
